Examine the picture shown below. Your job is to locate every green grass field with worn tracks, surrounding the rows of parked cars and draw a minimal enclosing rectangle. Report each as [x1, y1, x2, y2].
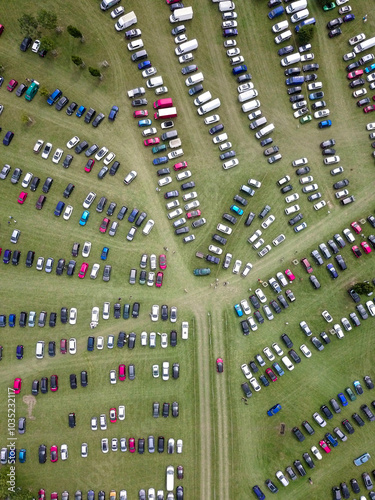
[0, 0, 375, 500]
